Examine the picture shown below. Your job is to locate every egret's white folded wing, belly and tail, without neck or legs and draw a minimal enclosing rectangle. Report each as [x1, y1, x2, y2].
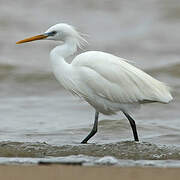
[71, 51, 172, 114]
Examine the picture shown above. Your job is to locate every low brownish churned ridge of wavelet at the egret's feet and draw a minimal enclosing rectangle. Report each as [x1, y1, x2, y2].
[0, 141, 180, 160]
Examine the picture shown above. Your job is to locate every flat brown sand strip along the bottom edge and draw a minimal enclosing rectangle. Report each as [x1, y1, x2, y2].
[0, 165, 180, 180]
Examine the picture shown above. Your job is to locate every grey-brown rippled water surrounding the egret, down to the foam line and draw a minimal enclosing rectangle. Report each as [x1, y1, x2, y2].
[0, 0, 180, 164]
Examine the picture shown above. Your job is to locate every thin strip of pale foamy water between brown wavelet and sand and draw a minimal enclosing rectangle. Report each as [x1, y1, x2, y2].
[0, 155, 180, 168]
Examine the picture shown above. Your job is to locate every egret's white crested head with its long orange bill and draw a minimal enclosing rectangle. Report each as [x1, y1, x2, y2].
[16, 23, 87, 48]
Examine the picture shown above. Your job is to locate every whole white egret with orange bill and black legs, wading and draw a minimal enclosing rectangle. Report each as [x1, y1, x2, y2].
[16, 23, 173, 144]
